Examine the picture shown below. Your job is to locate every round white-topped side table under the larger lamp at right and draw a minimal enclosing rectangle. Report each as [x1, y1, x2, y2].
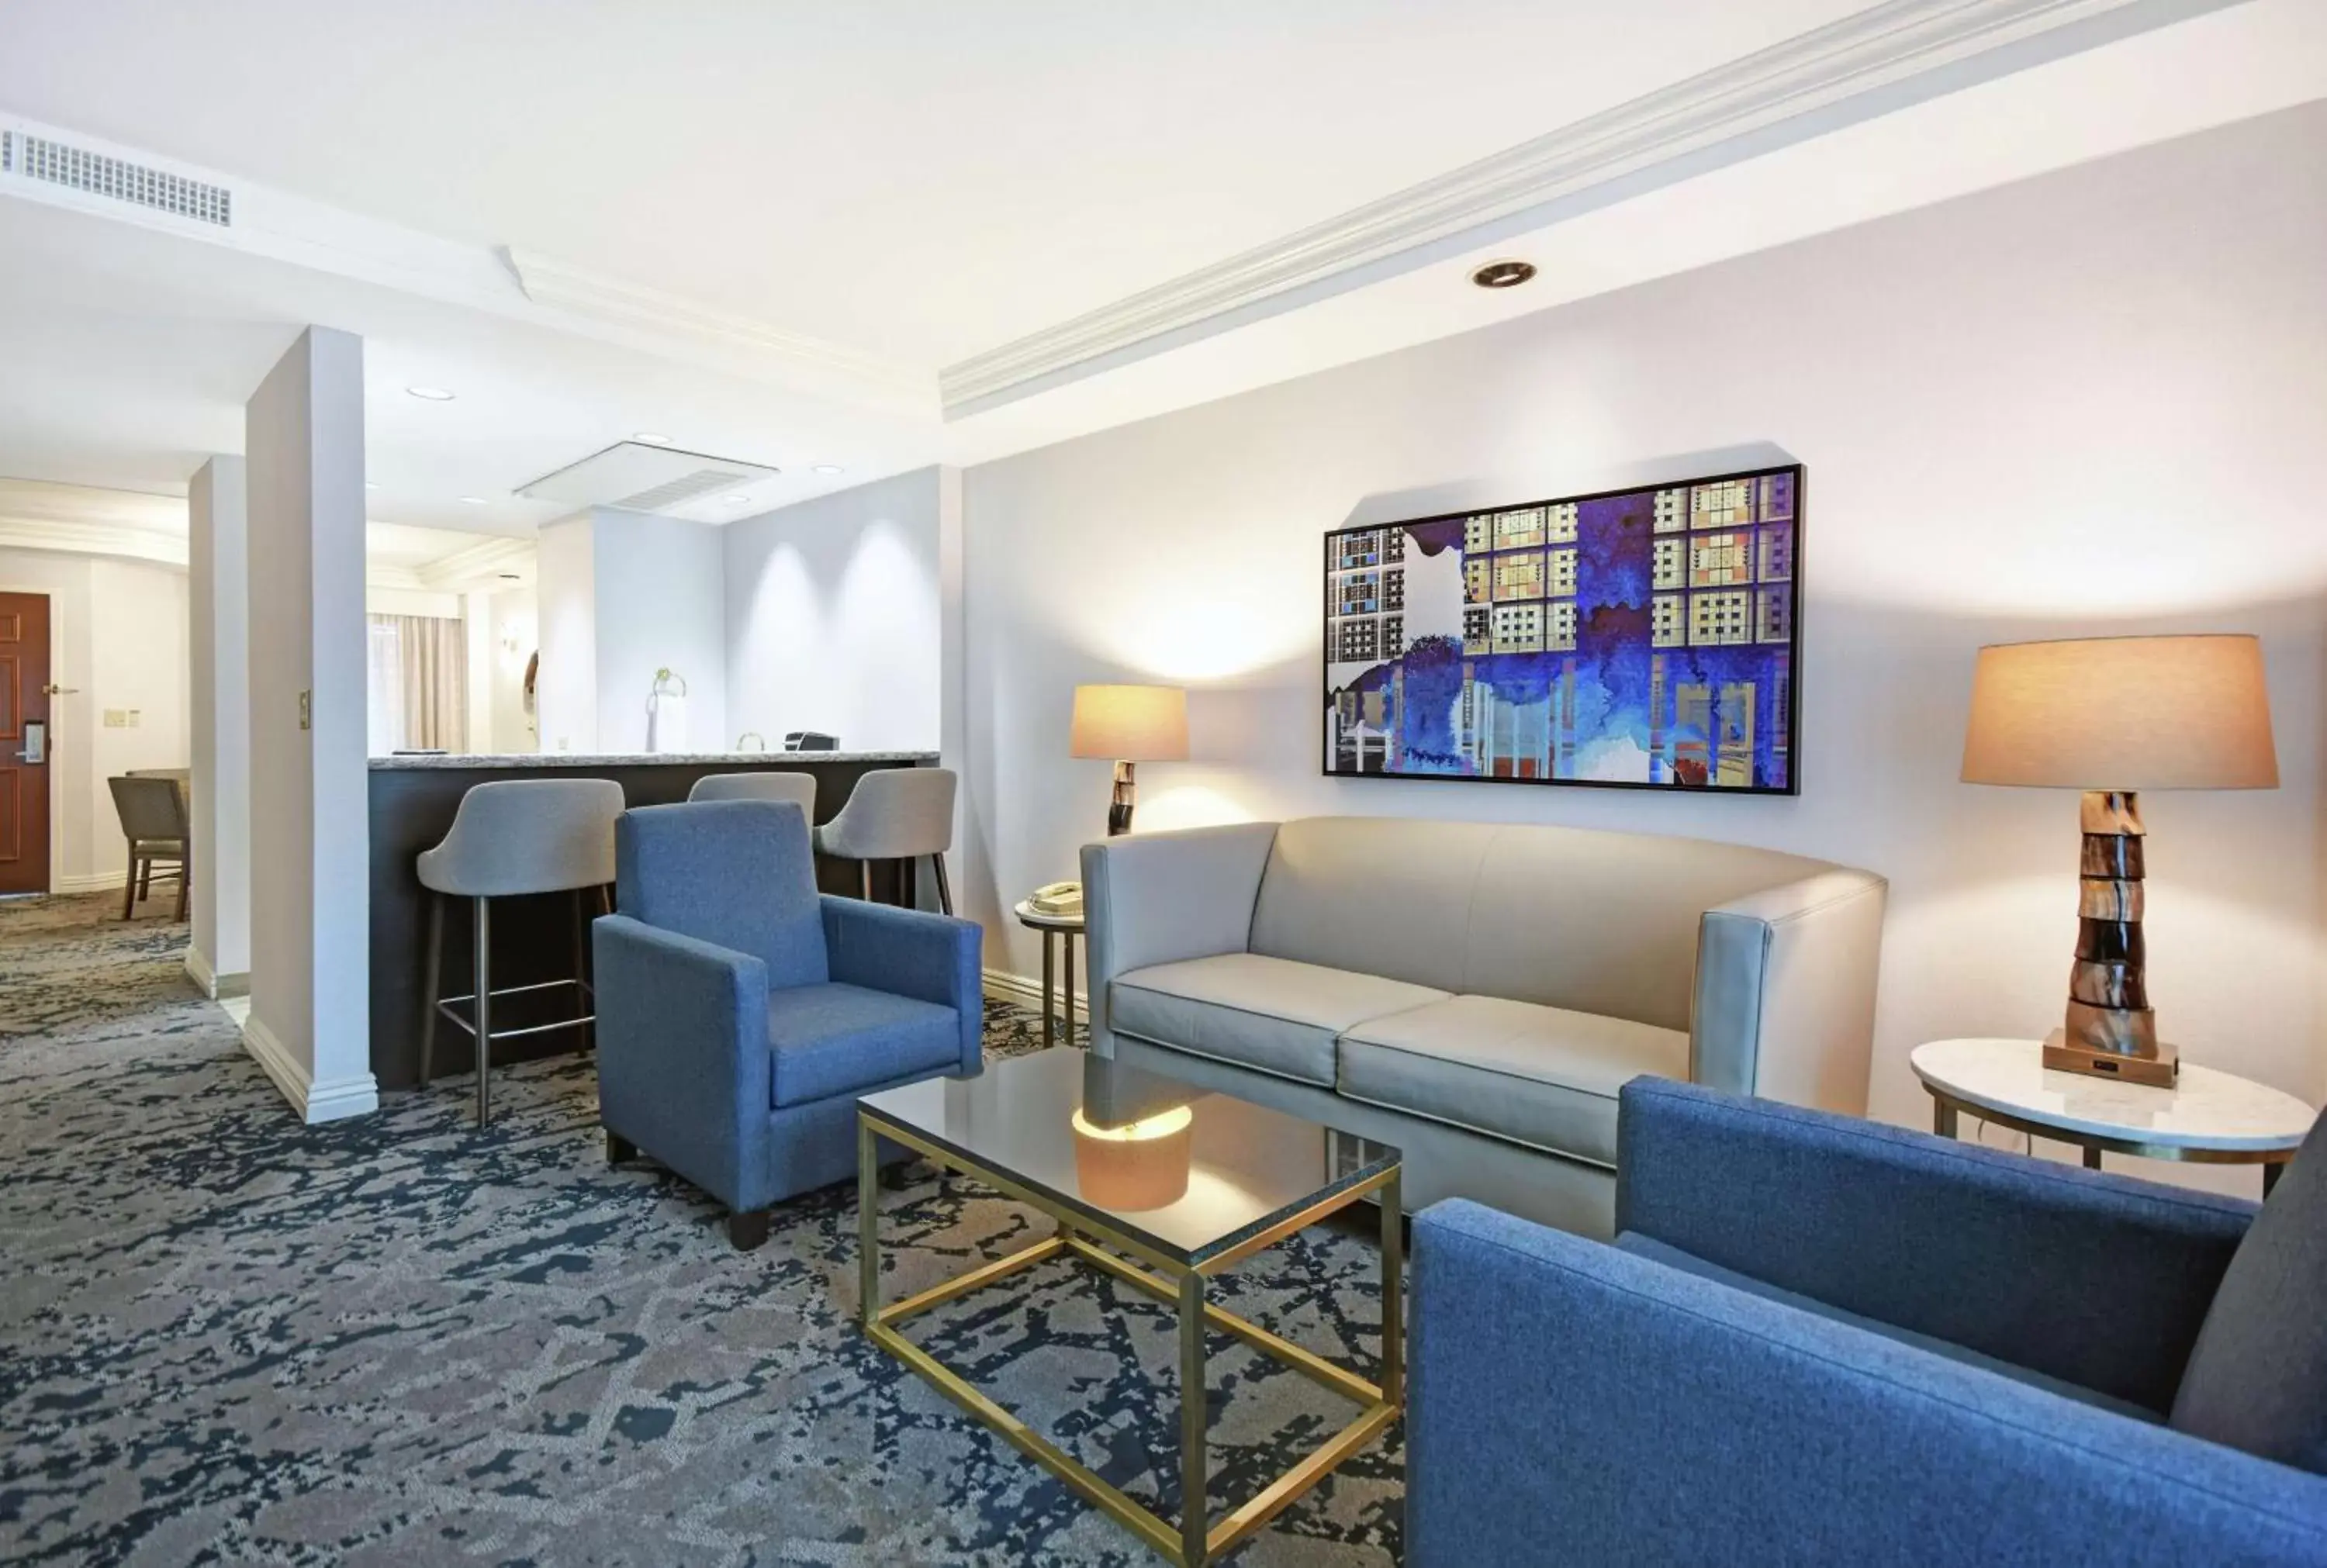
[1908, 1040, 2318, 1196]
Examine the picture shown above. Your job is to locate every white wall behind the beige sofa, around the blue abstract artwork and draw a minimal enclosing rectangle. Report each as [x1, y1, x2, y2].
[959, 105, 2327, 1173]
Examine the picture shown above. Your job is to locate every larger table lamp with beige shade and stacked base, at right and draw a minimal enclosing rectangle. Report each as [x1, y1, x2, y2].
[1964, 635, 2278, 1086]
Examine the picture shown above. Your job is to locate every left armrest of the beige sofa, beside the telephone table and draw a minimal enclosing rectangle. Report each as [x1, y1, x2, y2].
[1068, 821, 1278, 1056]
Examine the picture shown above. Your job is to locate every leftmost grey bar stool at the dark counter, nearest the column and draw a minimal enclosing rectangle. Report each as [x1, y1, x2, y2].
[419, 779, 621, 1126]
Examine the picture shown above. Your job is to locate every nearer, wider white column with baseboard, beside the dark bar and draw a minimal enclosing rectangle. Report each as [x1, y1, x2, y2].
[242, 326, 379, 1121]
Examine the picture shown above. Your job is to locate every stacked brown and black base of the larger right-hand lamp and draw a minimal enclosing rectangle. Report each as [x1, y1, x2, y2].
[2043, 789, 2180, 1089]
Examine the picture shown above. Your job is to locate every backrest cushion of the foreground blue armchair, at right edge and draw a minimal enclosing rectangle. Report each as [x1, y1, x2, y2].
[2173, 1098, 2327, 1475]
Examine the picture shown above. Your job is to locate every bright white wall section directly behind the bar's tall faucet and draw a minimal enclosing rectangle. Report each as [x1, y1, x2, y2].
[591, 507, 735, 751]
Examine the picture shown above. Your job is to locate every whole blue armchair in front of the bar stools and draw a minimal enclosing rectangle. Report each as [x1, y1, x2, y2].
[591, 800, 984, 1247]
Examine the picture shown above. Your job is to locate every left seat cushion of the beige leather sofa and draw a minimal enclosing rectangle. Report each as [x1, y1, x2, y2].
[1108, 954, 1447, 1089]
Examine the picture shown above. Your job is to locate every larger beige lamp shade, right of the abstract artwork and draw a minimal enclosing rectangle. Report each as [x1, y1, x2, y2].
[1964, 635, 2278, 791]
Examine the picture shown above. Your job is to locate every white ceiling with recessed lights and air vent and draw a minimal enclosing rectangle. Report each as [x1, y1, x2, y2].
[0, 0, 2327, 533]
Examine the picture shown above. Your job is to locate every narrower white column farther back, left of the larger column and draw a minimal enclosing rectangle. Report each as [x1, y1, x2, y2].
[186, 456, 251, 996]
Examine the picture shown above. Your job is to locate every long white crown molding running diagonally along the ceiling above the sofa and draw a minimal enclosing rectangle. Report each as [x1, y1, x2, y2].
[938, 0, 2246, 419]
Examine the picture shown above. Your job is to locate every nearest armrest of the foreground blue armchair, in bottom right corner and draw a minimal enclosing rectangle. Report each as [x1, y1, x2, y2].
[1406, 1200, 2327, 1568]
